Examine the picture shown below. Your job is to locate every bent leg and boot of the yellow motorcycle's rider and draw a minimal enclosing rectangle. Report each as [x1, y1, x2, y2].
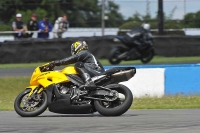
[75, 62, 96, 90]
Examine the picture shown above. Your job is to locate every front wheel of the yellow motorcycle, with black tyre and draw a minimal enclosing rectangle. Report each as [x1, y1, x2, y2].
[14, 89, 47, 117]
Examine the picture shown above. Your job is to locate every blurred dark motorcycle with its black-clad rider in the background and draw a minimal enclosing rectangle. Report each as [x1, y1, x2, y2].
[108, 27, 155, 65]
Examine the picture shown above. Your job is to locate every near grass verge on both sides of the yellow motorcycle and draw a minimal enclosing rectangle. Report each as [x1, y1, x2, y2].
[0, 77, 200, 110]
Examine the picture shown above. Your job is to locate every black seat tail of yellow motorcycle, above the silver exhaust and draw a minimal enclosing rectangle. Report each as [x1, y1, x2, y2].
[101, 67, 135, 75]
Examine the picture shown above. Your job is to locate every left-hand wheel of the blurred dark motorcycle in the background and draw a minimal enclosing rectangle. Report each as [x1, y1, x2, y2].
[108, 48, 122, 65]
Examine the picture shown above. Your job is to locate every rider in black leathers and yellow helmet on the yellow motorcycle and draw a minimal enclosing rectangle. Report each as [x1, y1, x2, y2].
[49, 41, 105, 90]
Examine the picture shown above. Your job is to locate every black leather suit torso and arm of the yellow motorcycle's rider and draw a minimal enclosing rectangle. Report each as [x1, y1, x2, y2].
[55, 50, 105, 80]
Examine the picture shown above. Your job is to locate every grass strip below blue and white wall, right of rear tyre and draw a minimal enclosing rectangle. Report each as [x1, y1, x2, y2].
[131, 95, 200, 109]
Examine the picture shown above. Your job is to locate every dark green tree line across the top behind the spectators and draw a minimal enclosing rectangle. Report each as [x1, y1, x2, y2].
[0, 0, 200, 30]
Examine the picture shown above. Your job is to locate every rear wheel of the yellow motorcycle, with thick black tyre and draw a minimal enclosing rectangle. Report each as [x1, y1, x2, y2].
[94, 84, 133, 116]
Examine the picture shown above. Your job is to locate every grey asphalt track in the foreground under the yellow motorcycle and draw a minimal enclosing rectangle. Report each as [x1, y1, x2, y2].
[0, 109, 200, 133]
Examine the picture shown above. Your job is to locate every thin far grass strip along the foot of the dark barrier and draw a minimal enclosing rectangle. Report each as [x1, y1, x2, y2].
[0, 56, 200, 69]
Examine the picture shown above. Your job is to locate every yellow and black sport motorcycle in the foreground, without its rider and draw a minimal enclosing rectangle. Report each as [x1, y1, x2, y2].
[14, 63, 136, 117]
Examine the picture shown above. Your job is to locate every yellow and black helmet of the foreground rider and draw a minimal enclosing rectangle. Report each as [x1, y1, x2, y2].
[71, 41, 88, 55]
